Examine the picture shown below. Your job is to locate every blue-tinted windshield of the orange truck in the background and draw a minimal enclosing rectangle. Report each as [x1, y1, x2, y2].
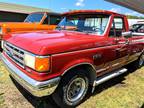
[24, 13, 44, 23]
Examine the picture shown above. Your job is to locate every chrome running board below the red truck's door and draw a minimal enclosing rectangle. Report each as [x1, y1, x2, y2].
[92, 68, 128, 93]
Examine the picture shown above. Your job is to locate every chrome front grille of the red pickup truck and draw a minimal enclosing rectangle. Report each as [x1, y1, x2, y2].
[4, 42, 24, 68]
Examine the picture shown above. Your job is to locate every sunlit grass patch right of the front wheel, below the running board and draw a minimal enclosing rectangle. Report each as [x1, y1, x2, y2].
[79, 68, 144, 108]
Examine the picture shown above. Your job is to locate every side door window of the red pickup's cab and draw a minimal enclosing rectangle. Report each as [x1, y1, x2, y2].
[109, 17, 126, 37]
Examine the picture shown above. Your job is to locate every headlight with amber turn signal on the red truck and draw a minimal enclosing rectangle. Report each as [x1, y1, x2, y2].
[24, 54, 50, 72]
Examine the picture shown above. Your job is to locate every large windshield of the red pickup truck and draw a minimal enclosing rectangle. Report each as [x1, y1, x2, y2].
[57, 14, 109, 34]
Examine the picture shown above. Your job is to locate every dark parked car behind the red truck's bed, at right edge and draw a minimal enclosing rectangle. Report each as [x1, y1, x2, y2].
[130, 21, 144, 36]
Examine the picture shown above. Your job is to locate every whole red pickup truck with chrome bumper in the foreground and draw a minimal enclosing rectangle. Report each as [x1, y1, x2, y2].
[1, 10, 144, 108]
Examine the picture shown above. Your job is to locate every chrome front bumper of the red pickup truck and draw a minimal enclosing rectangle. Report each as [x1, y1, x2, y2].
[0, 54, 60, 97]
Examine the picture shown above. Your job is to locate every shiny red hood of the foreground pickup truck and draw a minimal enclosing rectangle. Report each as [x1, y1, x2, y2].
[7, 31, 105, 55]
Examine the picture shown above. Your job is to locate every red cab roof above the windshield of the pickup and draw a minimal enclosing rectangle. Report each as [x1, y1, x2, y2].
[62, 10, 125, 16]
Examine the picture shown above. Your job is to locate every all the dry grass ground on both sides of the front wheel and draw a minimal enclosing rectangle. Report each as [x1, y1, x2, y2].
[0, 62, 144, 108]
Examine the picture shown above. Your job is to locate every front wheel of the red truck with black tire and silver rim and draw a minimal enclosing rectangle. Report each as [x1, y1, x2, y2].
[52, 69, 89, 108]
